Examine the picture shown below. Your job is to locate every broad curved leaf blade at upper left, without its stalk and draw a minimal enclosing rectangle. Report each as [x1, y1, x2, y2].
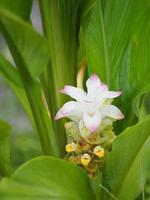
[0, 9, 49, 79]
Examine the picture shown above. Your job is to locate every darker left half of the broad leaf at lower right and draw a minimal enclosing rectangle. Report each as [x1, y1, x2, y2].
[104, 117, 150, 199]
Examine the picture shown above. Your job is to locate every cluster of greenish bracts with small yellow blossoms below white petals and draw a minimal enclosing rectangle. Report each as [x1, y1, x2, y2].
[65, 122, 115, 176]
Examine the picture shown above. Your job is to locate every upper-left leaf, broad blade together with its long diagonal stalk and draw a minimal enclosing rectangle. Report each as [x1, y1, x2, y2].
[0, 9, 58, 155]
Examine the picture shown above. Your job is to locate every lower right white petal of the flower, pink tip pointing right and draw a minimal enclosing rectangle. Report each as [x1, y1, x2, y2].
[102, 105, 124, 119]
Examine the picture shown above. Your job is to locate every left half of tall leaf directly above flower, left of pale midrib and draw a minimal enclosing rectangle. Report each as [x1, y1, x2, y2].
[83, 0, 108, 82]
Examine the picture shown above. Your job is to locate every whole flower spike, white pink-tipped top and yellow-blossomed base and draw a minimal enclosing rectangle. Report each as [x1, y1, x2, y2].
[55, 73, 124, 176]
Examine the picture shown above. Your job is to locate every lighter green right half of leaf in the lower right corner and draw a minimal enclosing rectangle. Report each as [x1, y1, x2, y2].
[115, 138, 150, 200]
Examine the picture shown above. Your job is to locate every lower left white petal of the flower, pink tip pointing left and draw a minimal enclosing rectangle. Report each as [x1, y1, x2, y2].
[55, 101, 82, 120]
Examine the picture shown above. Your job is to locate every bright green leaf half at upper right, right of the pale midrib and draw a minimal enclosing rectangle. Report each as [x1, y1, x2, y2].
[104, 0, 149, 88]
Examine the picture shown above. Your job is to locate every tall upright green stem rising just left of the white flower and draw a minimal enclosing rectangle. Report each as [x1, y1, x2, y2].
[39, 0, 67, 156]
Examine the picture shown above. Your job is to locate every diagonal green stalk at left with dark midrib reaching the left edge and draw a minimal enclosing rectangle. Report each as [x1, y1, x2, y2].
[1, 14, 59, 156]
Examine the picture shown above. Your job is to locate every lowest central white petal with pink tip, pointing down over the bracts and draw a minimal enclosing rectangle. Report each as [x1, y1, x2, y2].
[83, 112, 101, 132]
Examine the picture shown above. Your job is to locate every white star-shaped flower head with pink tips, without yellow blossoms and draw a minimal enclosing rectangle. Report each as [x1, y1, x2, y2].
[55, 74, 124, 133]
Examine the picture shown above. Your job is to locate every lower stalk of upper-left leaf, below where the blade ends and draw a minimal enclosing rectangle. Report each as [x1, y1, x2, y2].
[25, 82, 58, 156]
